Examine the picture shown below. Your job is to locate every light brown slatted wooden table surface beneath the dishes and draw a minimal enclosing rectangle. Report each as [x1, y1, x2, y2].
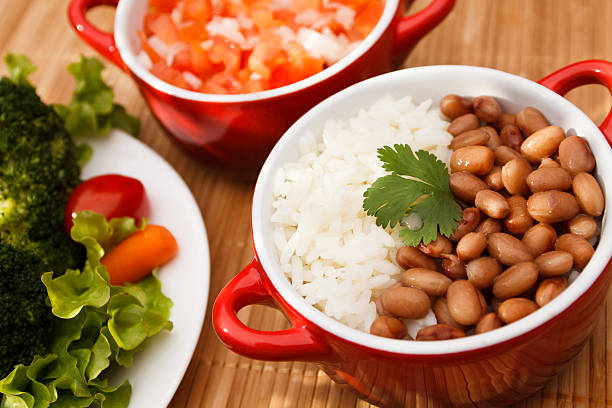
[0, 0, 612, 408]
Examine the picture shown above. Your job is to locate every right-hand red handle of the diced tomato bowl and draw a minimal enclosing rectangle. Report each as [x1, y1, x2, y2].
[393, 0, 455, 66]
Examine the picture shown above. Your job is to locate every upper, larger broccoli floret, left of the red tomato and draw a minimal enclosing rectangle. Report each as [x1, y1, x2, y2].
[0, 78, 80, 241]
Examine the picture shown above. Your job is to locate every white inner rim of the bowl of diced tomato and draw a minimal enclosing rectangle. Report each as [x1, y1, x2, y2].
[114, 0, 399, 102]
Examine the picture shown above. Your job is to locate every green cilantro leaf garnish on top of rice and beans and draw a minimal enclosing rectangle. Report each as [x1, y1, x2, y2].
[363, 144, 461, 246]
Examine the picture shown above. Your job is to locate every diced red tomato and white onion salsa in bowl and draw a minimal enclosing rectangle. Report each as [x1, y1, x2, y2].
[138, 0, 384, 94]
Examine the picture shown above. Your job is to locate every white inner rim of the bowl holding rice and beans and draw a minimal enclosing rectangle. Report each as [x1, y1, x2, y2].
[252, 66, 612, 354]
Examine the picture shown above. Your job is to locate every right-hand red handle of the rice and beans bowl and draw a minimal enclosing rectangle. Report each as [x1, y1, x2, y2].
[538, 60, 612, 147]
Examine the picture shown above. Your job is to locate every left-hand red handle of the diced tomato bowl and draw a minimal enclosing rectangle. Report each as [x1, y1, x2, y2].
[68, 0, 127, 71]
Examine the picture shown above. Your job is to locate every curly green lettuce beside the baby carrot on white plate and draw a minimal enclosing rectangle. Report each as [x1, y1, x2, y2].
[0, 211, 172, 408]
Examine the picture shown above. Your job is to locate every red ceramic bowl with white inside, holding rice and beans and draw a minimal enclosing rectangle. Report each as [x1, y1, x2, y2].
[213, 61, 612, 407]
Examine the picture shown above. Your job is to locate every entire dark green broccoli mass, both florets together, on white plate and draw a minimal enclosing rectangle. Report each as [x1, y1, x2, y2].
[0, 78, 85, 378]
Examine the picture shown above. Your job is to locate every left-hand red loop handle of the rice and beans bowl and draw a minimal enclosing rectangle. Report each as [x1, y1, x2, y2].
[213, 259, 330, 361]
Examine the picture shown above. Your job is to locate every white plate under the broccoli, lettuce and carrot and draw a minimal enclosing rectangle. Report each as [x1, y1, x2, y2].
[82, 130, 210, 408]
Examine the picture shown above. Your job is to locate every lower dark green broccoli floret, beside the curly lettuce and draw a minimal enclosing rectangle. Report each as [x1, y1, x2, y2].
[0, 241, 56, 378]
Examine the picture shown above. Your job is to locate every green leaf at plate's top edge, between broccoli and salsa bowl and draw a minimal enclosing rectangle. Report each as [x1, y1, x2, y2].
[55, 56, 140, 136]
